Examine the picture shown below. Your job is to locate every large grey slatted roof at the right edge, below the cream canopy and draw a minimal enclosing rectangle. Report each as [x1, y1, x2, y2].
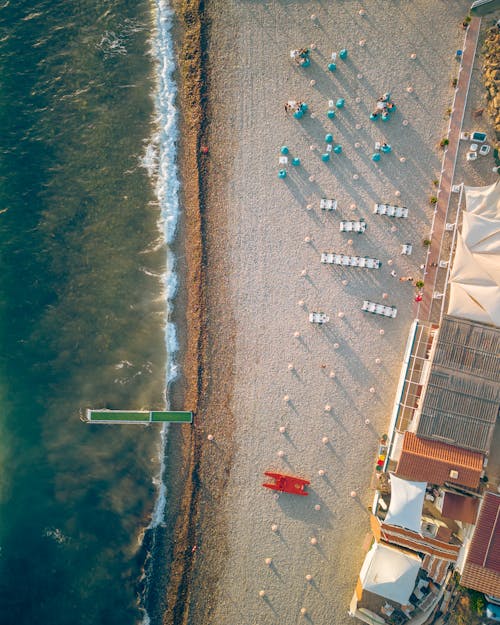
[416, 315, 500, 453]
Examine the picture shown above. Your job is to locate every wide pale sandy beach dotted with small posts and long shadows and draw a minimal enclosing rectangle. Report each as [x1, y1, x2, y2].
[189, 0, 468, 625]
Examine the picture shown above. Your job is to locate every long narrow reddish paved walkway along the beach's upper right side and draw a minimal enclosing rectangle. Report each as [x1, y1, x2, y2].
[416, 17, 481, 322]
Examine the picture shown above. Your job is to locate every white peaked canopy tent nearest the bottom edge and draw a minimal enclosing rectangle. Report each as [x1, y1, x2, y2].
[359, 543, 422, 605]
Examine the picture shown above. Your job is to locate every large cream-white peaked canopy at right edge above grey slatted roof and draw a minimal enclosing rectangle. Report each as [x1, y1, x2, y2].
[448, 182, 500, 327]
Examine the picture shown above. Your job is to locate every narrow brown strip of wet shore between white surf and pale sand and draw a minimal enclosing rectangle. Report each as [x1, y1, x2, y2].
[158, 0, 215, 625]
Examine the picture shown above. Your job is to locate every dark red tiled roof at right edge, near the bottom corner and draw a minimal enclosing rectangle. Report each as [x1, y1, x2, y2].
[461, 493, 500, 596]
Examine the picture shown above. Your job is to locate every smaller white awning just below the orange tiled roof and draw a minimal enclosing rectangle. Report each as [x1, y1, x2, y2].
[385, 473, 427, 534]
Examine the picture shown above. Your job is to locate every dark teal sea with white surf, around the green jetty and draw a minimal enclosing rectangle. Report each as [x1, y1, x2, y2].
[0, 0, 177, 625]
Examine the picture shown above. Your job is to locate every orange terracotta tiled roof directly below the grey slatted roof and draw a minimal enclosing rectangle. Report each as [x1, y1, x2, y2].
[396, 432, 483, 489]
